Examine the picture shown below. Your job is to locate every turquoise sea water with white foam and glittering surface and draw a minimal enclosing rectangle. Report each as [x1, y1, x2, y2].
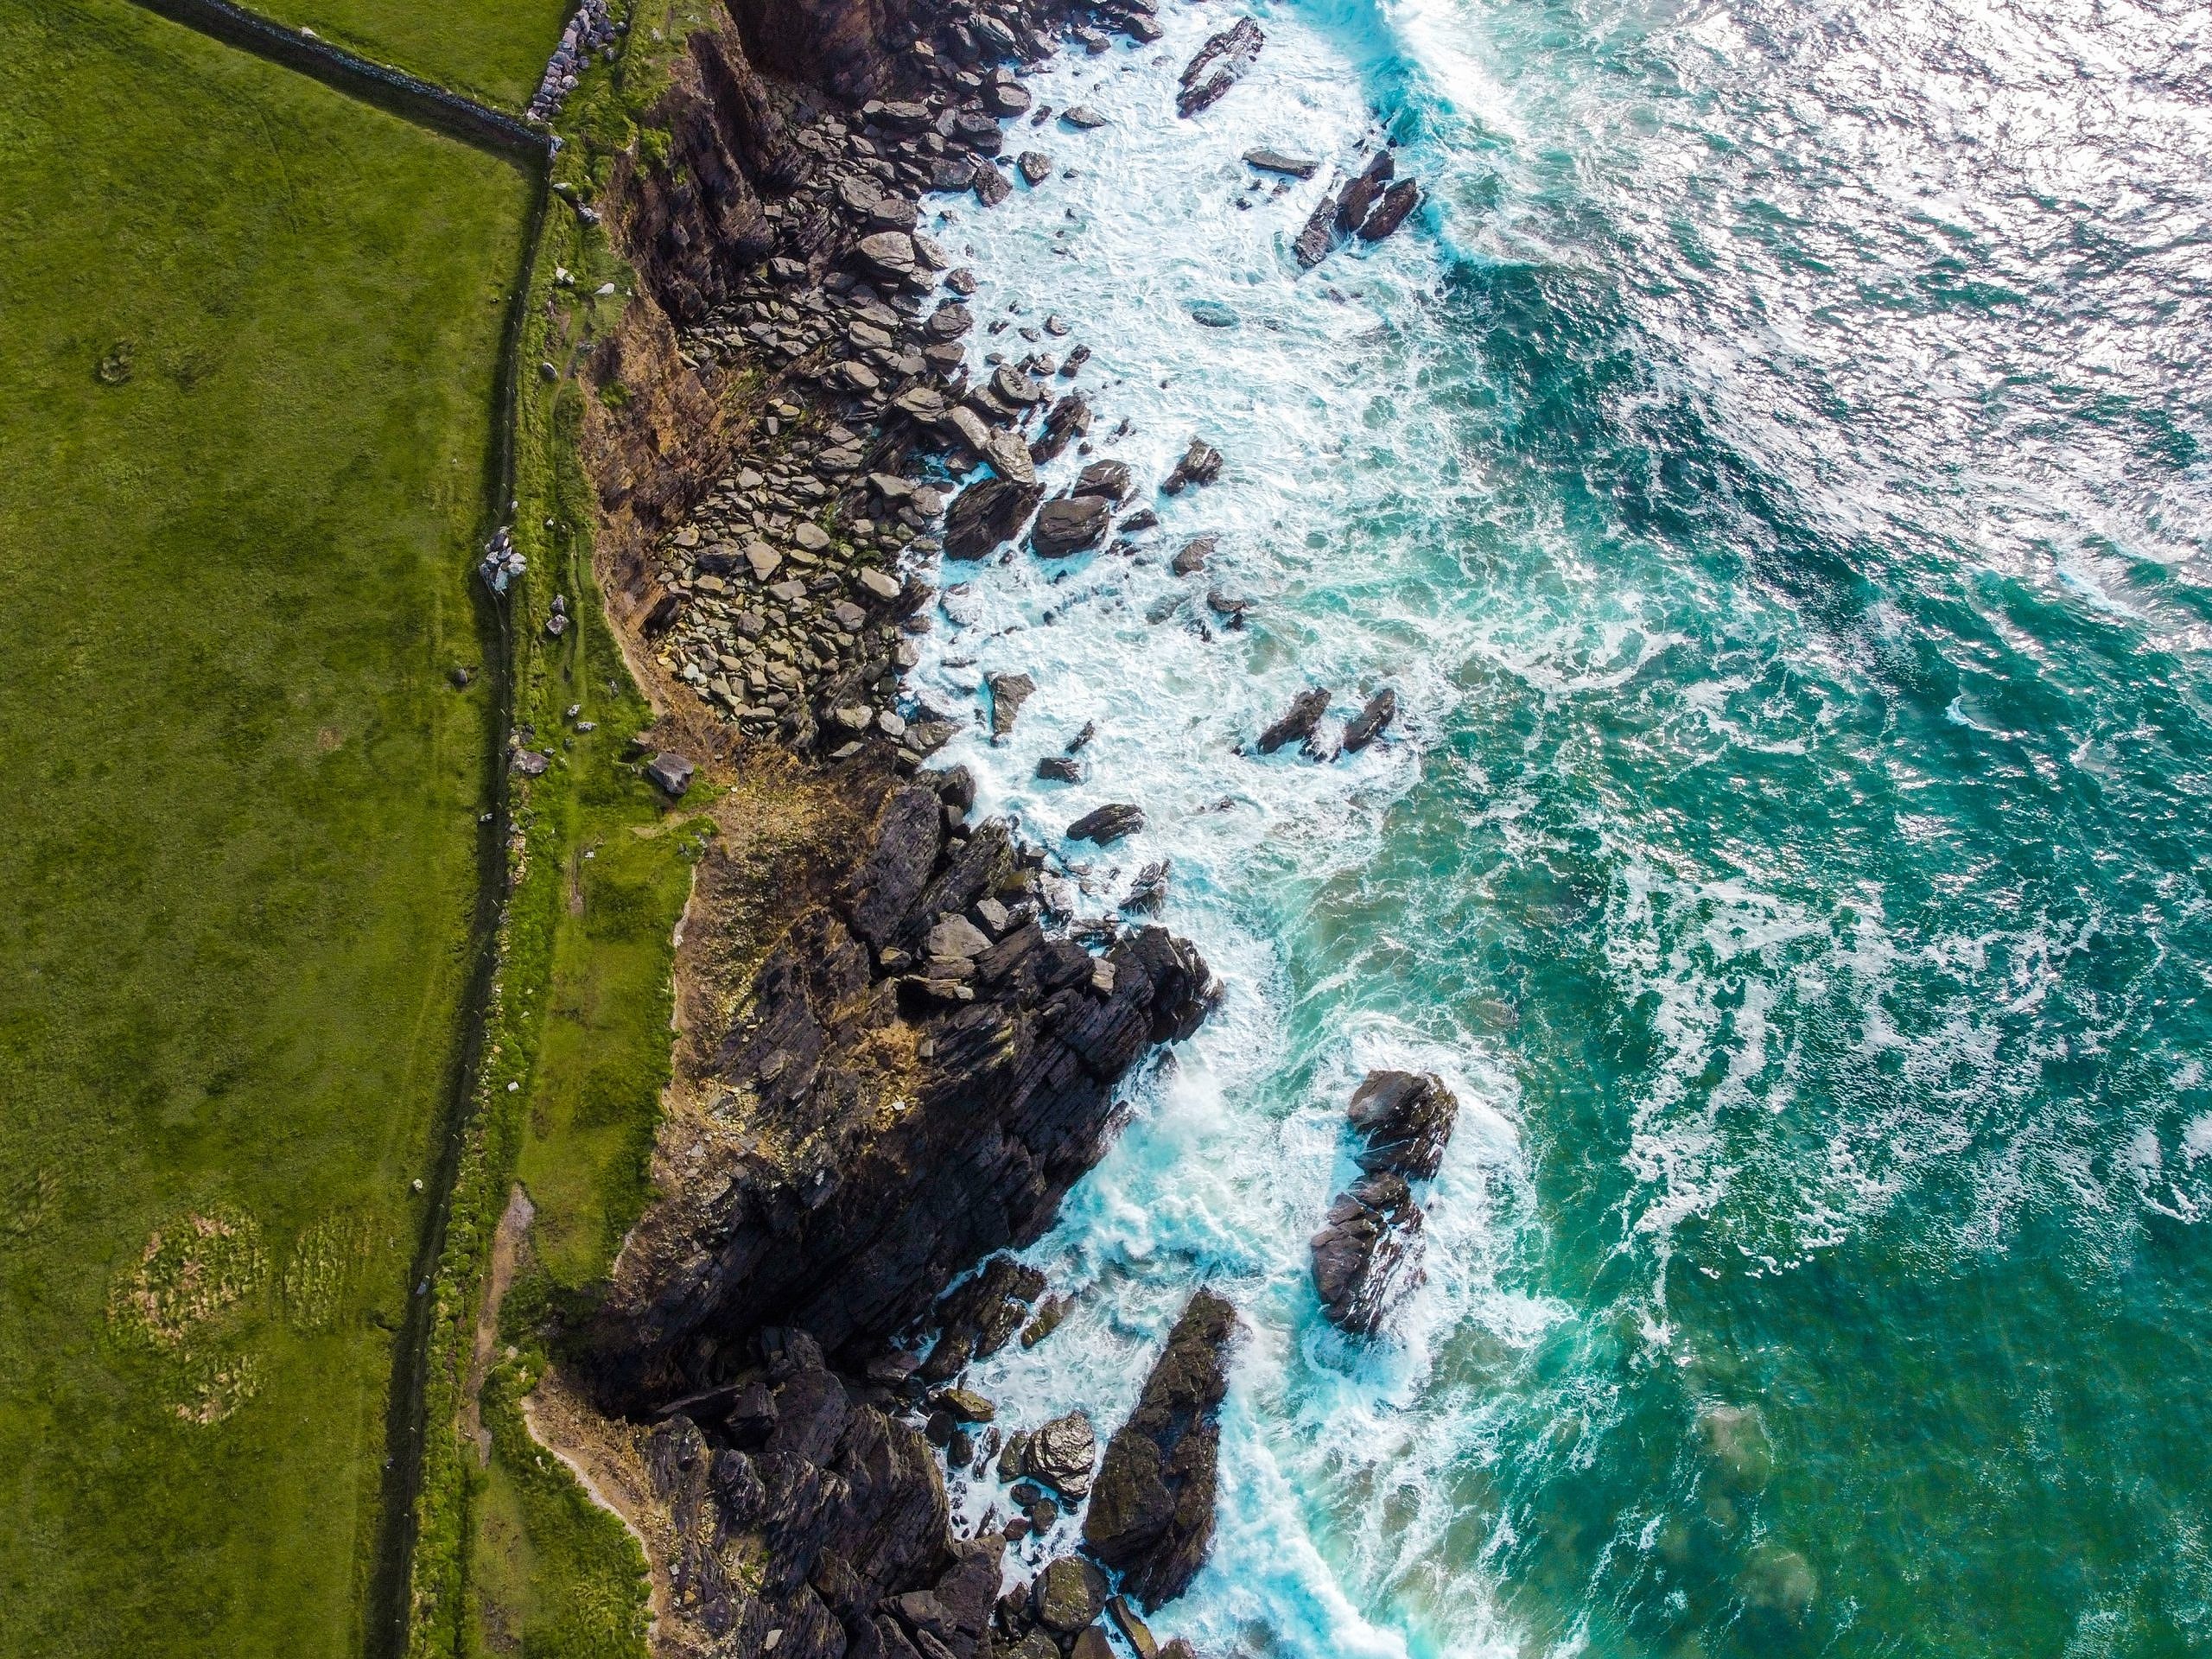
[902, 0, 2212, 1659]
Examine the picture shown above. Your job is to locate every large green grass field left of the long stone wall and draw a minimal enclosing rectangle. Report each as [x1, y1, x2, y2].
[0, 0, 531, 1656]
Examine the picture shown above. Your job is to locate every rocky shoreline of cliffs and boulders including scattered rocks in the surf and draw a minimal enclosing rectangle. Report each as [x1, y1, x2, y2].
[544, 0, 1414, 1659]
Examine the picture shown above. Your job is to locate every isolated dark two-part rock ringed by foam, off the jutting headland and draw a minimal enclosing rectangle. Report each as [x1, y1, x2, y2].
[1312, 1071, 1460, 1336]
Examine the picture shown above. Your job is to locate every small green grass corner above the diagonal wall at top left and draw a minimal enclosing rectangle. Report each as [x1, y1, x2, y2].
[241, 0, 575, 111]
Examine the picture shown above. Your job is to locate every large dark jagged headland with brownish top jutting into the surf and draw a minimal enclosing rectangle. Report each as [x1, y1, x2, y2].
[593, 783, 1210, 1411]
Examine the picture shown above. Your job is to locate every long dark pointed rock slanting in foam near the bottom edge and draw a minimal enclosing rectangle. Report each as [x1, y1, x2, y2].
[1084, 1289, 1236, 1611]
